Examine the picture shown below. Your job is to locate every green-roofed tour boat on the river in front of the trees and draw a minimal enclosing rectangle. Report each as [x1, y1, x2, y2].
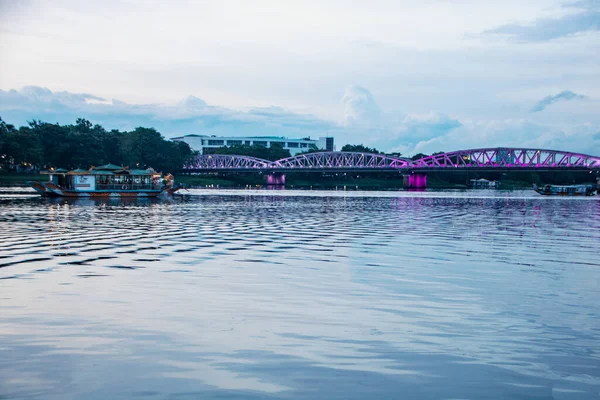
[30, 164, 183, 198]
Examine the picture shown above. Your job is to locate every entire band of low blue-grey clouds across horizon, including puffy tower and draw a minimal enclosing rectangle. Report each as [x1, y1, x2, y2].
[0, 86, 600, 155]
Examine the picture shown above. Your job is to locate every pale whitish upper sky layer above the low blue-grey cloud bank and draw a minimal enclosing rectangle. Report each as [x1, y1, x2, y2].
[0, 0, 600, 115]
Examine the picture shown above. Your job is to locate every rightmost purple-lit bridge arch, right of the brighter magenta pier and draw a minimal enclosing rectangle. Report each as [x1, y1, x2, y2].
[410, 147, 600, 169]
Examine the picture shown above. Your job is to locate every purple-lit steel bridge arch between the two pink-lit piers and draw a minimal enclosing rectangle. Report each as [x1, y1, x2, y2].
[270, 151, 408, 169]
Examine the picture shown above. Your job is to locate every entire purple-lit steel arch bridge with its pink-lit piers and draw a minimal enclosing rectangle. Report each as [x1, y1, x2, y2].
[181, 147, 600, 188]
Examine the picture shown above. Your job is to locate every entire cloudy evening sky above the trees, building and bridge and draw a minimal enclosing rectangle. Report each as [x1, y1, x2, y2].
[0, 0, 600, 155]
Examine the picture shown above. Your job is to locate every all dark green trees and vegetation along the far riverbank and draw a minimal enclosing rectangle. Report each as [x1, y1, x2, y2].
[0, 118, 595, 190]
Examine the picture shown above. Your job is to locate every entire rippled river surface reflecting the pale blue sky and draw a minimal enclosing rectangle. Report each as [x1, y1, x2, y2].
[0, 191, 600, 399]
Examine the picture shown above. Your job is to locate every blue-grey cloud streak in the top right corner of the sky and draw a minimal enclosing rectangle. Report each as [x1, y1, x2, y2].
[484, 0, 600, 42]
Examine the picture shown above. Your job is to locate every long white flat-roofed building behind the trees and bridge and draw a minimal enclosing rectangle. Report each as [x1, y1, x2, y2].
[172, 134, 335, 156]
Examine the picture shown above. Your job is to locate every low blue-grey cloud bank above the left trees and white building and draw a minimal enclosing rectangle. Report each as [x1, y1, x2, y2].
[0, 86, 337, 137]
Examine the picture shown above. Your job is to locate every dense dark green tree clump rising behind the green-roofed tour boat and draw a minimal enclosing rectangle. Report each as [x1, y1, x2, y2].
[0, 118, 194, 172]
